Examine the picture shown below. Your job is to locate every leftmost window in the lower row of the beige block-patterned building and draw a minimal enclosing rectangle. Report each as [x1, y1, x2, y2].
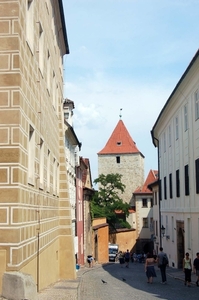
[28, 125, 35, 184]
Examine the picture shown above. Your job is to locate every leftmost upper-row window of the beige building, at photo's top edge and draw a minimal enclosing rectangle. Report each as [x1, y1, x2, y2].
[25, 0, 34, 51]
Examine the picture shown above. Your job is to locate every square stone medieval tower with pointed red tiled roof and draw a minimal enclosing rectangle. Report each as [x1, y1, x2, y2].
[98, 120, 144, 206]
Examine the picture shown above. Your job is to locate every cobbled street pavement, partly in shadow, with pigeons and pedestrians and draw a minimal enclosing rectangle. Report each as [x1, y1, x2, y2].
[78, 263, 199, 300]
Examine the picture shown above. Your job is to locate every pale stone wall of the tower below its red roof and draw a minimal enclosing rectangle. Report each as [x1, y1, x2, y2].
[98, 153, 144, 205]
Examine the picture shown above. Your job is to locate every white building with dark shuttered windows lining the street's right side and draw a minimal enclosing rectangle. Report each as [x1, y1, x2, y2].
[151, 51, 199, 268]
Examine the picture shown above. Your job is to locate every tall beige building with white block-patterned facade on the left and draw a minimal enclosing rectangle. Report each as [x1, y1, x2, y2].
[0, 0, 76, 290]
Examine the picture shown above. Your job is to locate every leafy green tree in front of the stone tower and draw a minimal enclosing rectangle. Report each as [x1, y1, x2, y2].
[91, 173, 131, 231]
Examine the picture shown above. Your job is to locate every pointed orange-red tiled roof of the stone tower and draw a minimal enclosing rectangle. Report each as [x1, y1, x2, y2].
[98, 120, 144, 157]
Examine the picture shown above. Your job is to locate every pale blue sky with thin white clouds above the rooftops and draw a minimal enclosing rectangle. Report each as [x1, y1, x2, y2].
[63, 0, 199, 184]
